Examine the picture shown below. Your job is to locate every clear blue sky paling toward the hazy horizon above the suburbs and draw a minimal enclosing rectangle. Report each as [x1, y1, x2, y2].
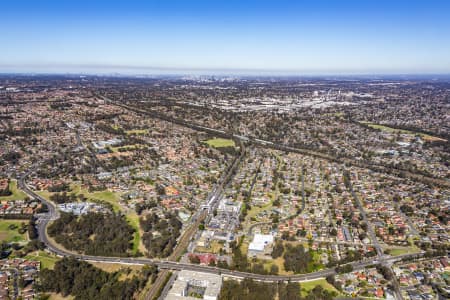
[0, 0, 450, 75]
